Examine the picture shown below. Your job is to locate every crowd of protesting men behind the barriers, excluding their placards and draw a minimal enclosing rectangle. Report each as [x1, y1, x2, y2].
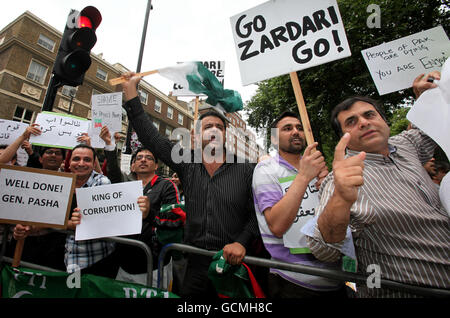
[0, 68, 450, 298]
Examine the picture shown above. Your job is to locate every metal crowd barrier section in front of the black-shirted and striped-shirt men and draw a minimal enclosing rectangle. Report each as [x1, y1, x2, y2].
[157, 243, 450, 298]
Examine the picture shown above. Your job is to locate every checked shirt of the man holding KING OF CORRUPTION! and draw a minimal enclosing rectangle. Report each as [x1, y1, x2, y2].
[64, 171, 115, 273]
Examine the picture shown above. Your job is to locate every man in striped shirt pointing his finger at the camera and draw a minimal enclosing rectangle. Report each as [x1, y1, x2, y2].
[308, 74, 450, 297]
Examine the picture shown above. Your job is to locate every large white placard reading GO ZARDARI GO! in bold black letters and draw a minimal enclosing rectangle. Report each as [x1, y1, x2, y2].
[231, 0, 351, 85]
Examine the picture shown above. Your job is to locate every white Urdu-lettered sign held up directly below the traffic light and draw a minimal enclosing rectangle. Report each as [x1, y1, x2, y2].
[30, 112, 89, 149]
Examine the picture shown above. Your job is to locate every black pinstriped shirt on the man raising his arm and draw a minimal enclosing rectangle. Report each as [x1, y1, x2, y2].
[124, 97, 259, 251]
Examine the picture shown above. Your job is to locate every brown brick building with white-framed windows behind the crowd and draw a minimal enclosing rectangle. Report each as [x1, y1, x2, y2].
[0, 11, 193, 174]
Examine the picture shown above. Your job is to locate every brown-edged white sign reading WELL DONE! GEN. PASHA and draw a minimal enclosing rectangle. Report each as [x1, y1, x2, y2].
[0, 165, 75, 228]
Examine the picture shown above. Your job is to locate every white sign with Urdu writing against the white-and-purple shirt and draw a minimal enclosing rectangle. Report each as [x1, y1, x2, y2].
[280, 176, 319, 248]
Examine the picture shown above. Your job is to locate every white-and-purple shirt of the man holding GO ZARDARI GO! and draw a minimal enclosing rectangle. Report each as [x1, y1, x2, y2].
[253, 154, 342, 291]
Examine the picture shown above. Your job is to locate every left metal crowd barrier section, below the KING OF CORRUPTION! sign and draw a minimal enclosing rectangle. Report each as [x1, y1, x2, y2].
[0, 229, 154, 287]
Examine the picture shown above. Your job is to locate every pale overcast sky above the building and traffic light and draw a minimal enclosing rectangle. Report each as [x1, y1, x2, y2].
[0, 0, 267, 140]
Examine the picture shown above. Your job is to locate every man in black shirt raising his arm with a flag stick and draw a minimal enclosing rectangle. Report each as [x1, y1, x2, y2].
[122, 73, 260, 297]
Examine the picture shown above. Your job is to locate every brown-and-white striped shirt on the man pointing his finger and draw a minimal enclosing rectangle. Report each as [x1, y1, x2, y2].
[309, 129, 450, 297]
